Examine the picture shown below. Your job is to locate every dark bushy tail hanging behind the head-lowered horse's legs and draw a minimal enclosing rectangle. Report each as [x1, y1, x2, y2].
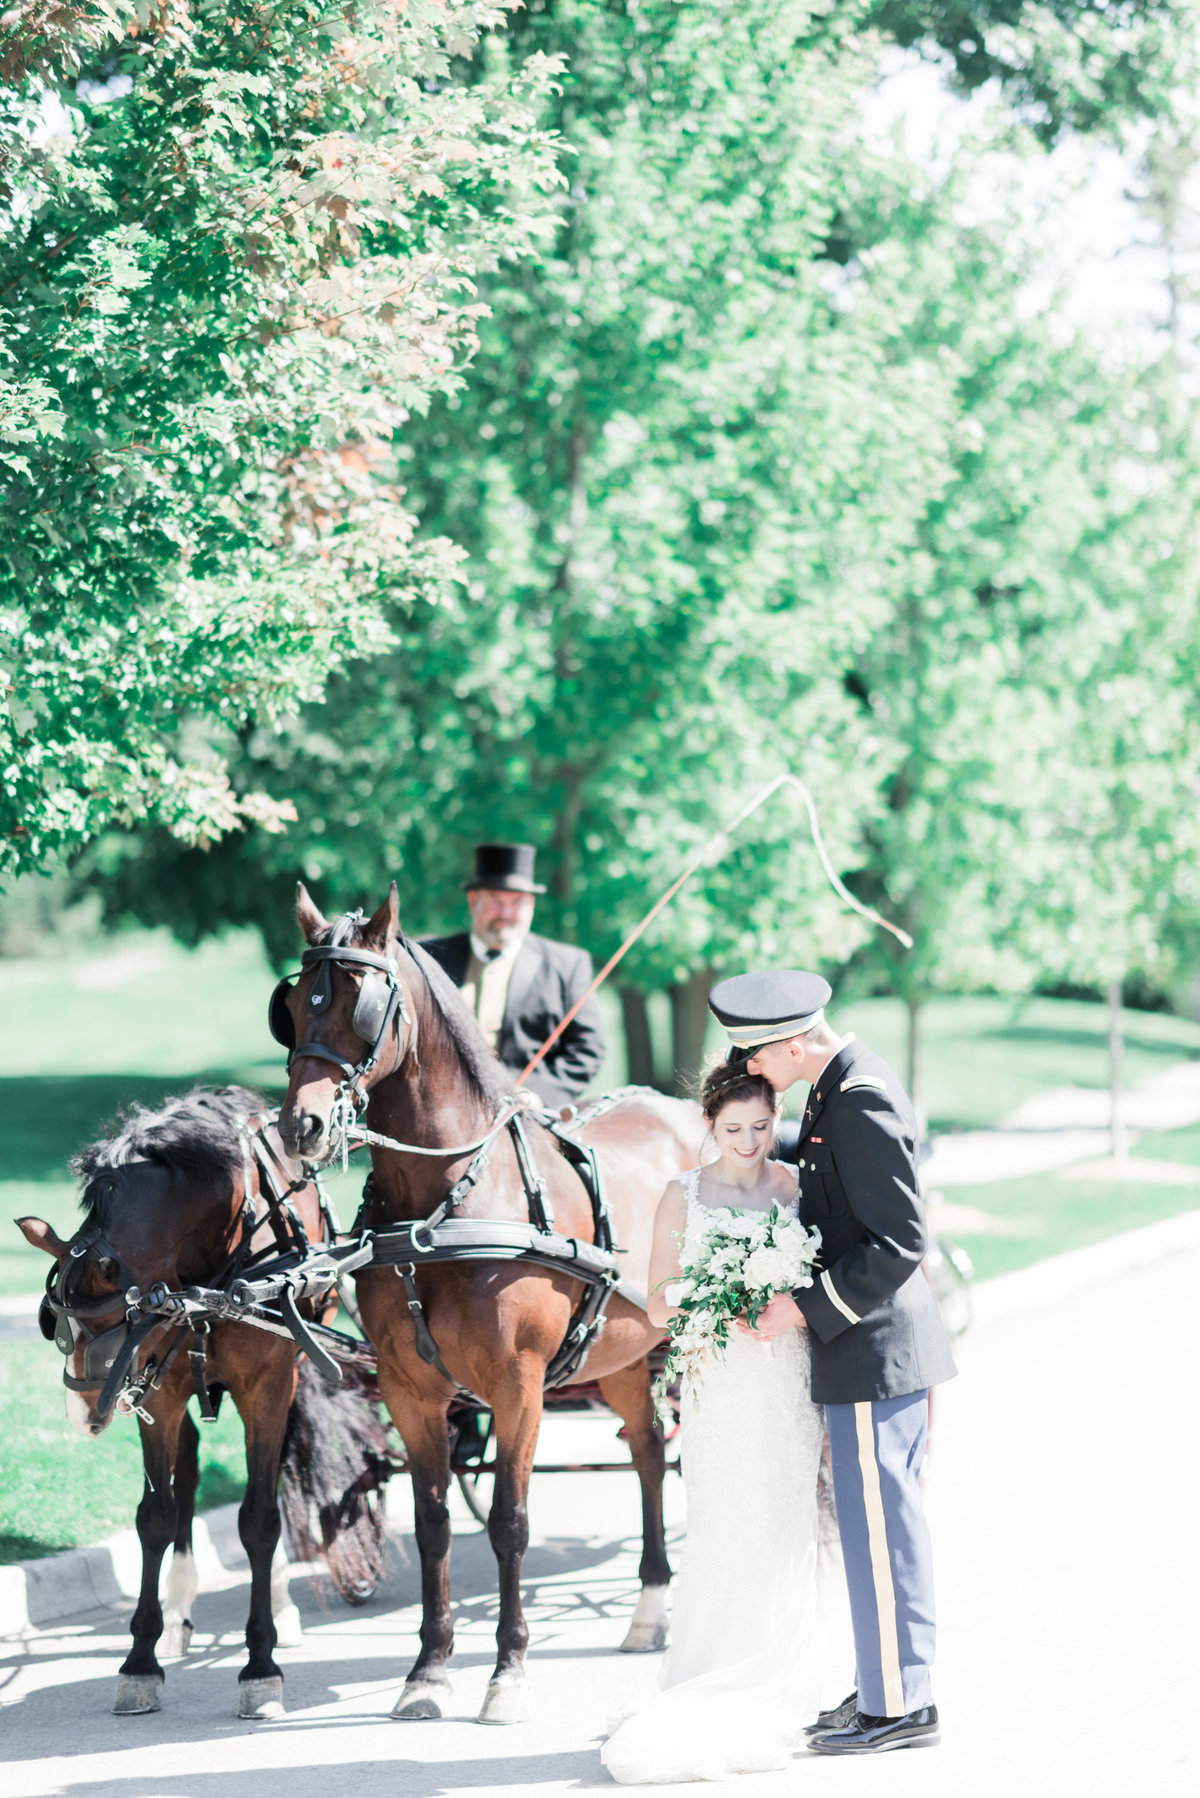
[279, 1359, 399, 1604]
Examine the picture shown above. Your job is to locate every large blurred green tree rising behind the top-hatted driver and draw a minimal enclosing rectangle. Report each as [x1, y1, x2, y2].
[82, 0, 939, 1014]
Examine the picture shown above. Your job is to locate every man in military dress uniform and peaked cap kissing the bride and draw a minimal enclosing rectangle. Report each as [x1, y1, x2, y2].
[709, 971, 955, 1755]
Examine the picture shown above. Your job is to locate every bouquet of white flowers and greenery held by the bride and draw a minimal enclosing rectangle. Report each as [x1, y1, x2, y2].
[655, 1205, 820, 1419]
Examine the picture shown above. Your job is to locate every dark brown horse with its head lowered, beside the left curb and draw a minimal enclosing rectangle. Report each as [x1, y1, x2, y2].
[16, 1086, 390, 1719]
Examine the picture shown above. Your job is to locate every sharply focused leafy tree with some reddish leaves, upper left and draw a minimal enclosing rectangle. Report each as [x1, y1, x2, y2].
[0, 0, 558, 874]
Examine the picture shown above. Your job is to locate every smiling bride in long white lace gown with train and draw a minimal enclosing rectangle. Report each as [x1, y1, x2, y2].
[601, 1063, 846, 1785]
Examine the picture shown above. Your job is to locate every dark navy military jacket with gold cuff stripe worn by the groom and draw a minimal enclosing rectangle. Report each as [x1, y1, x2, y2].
[792, 1037, 955, 1404]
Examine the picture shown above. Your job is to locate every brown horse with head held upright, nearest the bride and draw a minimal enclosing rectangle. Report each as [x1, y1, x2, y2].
[272, 885, 703, 1722]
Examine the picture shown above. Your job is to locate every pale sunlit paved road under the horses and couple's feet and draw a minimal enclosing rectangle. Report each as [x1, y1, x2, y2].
[0, 1250, 1200, 1798]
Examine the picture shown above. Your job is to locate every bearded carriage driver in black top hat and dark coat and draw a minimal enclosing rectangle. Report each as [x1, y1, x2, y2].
[423, 843, 604, 1109]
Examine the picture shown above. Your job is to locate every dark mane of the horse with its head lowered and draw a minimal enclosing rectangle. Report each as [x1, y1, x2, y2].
[70, 1086, 270, 1219]
